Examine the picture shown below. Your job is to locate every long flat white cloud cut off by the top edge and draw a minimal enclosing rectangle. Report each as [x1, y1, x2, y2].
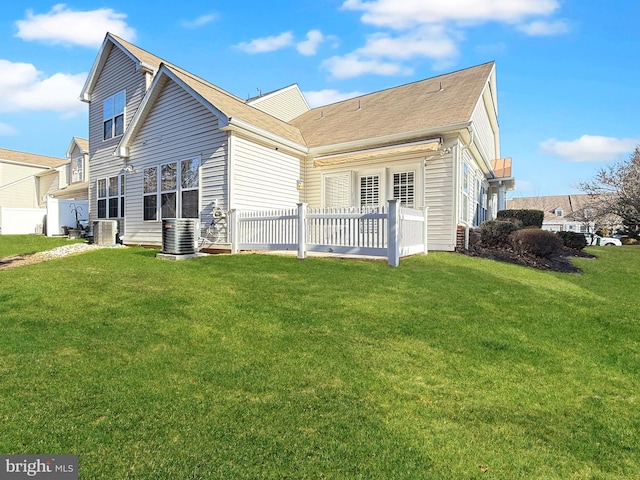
[342, 0, 560, 29]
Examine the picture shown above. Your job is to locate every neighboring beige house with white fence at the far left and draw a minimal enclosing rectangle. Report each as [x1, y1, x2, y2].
[0, 138, 89, 234]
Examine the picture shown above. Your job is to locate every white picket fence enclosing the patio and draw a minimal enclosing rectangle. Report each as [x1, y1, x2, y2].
[230, 200, 427, 266]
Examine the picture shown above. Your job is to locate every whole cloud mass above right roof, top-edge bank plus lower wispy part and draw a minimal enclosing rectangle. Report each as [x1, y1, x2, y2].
[336, 0, 568, 78]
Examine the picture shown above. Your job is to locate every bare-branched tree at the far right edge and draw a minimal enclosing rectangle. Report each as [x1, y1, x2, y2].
[580, 145, 640, 236]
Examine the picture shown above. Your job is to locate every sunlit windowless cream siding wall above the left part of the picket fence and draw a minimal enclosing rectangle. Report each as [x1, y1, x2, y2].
[232, 137, 302, 210]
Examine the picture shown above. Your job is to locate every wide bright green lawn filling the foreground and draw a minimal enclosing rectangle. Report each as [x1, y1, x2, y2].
[0, 237, 640, 479]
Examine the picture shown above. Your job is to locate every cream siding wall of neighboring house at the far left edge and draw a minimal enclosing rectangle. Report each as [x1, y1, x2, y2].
[0, 162, 46, 208]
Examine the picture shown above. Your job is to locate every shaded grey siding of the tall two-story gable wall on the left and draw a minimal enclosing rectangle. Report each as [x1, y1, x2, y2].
[89, 47, 146, 226]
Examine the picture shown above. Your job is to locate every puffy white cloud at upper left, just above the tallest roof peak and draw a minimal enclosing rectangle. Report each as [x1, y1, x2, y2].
[16, 3, 136, 48]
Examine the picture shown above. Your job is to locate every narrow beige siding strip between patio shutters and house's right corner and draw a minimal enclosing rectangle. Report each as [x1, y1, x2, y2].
[424, 153, 456, 251]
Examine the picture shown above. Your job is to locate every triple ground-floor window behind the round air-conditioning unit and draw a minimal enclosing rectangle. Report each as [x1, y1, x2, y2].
[143, 158, 200, 221]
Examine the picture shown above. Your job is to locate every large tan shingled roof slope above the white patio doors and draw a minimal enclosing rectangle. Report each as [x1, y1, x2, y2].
[290, 62, 495, 147]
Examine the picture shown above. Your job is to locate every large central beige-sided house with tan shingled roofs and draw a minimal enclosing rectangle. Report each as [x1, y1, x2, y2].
[81, 34, 515, 250]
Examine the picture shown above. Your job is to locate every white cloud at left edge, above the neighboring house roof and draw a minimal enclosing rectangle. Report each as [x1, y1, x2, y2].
[0, 59, 87, 116]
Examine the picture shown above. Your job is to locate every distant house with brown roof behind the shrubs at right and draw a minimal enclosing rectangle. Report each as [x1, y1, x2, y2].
[507, 194, 596, 233]
